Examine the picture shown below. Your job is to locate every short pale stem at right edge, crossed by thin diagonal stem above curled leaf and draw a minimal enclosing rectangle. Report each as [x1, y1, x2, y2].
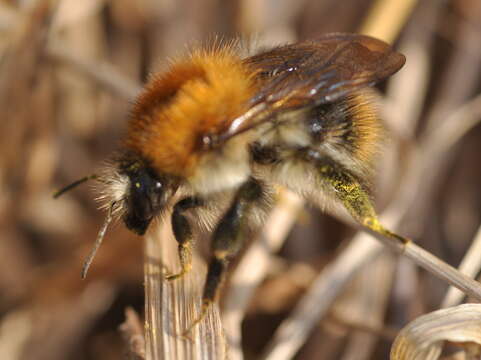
[441, 226, 481, 308]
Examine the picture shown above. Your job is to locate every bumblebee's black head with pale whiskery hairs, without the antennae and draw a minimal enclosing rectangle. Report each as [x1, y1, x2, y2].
[99, 158, 176, 235]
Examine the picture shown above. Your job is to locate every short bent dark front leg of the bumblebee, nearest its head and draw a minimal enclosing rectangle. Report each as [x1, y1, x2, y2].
[166, 197, 203, 280]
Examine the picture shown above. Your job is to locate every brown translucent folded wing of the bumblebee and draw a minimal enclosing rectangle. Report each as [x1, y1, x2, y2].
[221, 33, 405, 140]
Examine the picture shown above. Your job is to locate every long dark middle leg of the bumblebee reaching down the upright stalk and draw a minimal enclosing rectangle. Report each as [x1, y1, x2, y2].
[184, 178, 263, 335]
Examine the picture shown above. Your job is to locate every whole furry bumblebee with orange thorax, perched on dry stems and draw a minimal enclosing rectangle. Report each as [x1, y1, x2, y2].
[57, 33, 405, 330]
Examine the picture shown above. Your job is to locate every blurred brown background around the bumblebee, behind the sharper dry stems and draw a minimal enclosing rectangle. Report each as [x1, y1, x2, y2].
[0, 0, 481, 360]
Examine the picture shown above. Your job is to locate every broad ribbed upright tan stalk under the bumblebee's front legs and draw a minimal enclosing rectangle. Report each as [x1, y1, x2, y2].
[144, 222, 226, 360]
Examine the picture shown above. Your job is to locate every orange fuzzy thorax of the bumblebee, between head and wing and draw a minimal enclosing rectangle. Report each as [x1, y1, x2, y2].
[126, 48, 255, 177]
